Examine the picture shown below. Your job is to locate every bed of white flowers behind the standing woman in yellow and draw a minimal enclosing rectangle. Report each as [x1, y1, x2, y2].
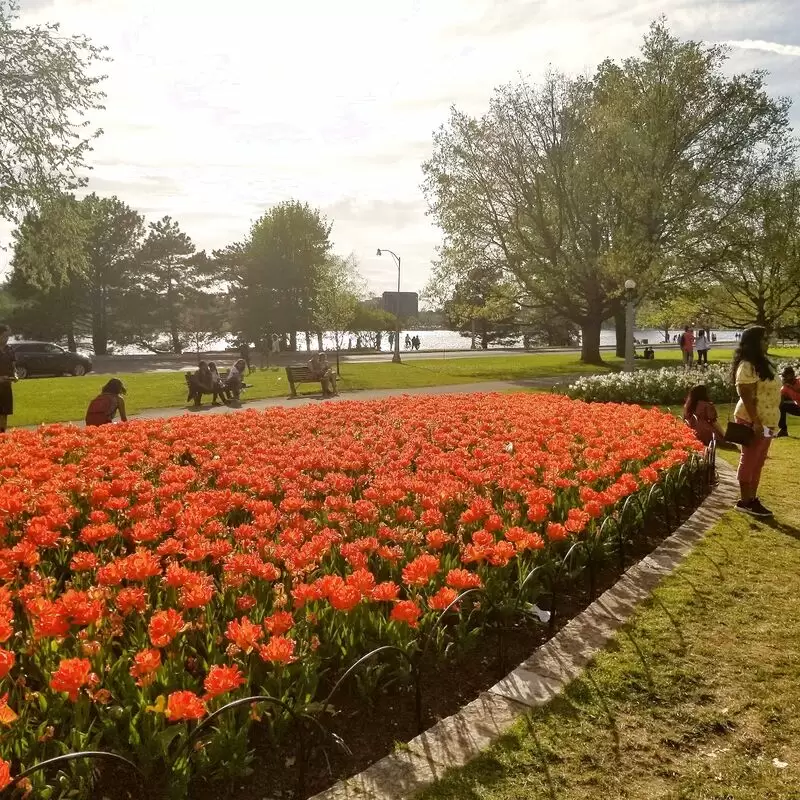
[565, 361, 798, 406]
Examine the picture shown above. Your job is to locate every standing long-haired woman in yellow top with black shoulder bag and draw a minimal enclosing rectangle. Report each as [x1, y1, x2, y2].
[733, 326, 781, 517]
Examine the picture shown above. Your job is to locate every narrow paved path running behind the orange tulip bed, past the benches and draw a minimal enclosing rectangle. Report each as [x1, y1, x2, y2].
[59, 375, 577, 427]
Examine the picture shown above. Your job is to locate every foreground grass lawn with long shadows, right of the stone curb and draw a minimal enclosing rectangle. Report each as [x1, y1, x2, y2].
[420, 428, 800, 800]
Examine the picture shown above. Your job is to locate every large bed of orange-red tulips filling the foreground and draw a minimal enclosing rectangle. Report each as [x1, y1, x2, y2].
[0, 394, 706, 798]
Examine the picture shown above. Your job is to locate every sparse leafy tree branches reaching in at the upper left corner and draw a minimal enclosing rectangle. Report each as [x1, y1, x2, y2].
[0, 0, 104, 221]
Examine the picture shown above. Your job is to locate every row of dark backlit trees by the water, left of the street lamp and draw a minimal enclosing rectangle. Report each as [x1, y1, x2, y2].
[2, 194, 395, 354]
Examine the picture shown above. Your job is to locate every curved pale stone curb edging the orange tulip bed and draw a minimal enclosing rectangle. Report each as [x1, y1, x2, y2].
[310, 459, 738, 800]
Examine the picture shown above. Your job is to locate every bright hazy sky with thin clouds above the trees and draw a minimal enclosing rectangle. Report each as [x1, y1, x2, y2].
[0, 0, 800, 293]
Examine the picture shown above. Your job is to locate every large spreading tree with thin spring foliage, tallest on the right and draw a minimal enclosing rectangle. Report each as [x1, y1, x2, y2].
[424, 22, 789, 361]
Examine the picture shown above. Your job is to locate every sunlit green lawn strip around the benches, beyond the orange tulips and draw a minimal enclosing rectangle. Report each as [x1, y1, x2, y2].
[11, 348, 800, 426]
